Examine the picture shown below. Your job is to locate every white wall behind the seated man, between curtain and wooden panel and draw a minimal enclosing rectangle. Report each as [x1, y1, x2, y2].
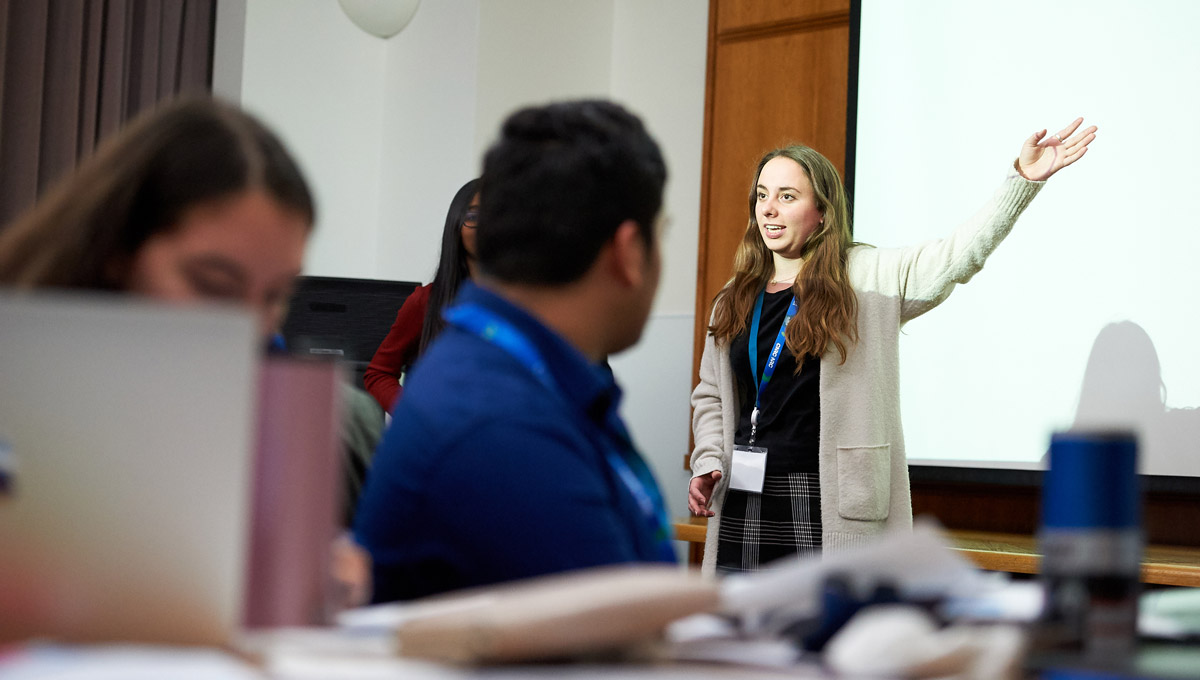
[215, 0, 708, 516]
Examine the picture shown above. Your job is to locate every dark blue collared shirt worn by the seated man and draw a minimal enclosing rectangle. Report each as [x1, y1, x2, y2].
[355, 283, 664, 602]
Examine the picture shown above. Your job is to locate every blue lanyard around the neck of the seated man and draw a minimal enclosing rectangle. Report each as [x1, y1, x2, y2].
[443, 303, 674, 561]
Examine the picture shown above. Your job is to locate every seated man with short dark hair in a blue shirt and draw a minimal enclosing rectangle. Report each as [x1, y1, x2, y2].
[355, 101, 674, 602]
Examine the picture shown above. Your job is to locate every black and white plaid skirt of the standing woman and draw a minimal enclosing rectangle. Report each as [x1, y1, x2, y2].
[716, 473, 821, 573]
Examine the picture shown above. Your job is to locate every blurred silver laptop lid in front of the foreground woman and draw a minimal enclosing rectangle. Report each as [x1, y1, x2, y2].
[0, 293, 258, 644]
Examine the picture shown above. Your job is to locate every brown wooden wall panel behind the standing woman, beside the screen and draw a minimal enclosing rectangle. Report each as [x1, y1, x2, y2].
[692, 0, 850, 381]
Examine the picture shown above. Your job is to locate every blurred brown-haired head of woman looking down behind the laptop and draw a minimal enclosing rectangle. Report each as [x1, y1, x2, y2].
[0, 100, 314, 338]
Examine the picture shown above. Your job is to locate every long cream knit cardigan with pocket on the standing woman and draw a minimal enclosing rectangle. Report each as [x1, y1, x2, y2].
[691, 171, 1044, 574]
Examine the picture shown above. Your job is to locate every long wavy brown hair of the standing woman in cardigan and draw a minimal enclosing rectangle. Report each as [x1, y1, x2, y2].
[708, 145, 858, 371]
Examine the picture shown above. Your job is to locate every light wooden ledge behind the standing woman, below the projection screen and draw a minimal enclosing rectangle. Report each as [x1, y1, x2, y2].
[674, 517, 1200, 588]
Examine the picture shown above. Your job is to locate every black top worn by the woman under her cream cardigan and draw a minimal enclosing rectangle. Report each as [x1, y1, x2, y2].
[730, 289, 821, 475]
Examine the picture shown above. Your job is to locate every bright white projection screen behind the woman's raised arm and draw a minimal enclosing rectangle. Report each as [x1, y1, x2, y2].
[853, 0, 1200, 476]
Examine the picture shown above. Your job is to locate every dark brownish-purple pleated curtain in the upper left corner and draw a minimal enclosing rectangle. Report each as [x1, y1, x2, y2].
[0, 0, 216, 228]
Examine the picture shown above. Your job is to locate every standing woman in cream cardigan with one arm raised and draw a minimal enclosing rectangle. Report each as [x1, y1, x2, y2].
[688, 119, 1097, 573]
